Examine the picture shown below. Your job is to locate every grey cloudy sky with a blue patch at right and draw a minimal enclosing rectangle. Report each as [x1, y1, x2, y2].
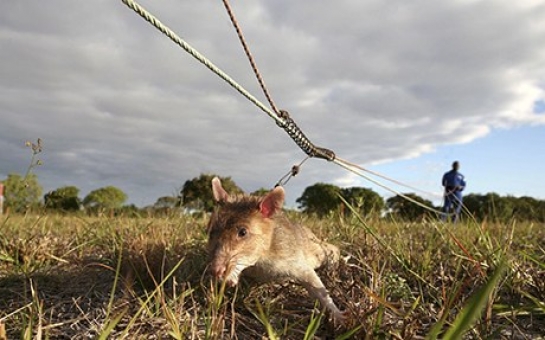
[0, 0, 545, 206]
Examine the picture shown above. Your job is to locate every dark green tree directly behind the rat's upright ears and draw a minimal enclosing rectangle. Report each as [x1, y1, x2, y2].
[180, 174, 242, 211]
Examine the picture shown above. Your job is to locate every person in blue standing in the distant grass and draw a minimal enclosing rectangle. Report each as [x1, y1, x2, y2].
[441, 161, 466, 223]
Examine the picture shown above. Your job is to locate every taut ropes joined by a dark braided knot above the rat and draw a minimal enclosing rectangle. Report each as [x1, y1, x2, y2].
[121, 0, 442, 214]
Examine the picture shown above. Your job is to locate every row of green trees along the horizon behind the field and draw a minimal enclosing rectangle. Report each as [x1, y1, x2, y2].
[2, 173, 545, 222]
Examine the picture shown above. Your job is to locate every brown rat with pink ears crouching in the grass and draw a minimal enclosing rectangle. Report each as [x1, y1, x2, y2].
[208, 178, 343, 319]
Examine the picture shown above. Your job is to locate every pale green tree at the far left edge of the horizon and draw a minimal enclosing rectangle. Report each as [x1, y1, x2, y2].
[3, 173, 43, 213]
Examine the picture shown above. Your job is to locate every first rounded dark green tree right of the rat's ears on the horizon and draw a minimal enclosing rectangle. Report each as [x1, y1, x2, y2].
[295, 183, 341, 217]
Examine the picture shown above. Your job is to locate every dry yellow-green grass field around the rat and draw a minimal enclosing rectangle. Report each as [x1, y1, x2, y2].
[0, 214, 545, 339]
